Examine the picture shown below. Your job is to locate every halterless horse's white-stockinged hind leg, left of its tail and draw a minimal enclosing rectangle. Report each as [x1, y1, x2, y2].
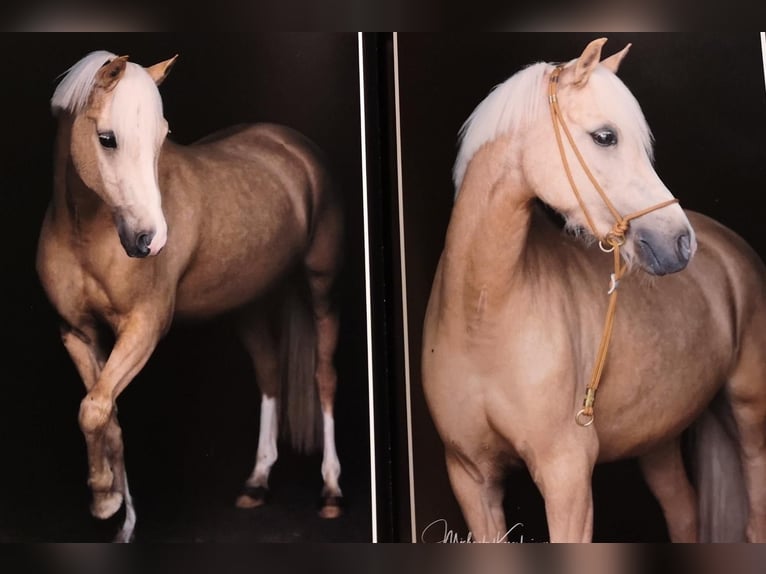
[236, 306, 281, 508]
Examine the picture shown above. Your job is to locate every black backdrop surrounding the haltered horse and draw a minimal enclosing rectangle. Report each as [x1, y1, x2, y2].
[398, 33, 766, 542]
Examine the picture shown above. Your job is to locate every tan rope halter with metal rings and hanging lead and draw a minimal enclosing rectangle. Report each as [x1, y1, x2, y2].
[548, 66, 678, 427]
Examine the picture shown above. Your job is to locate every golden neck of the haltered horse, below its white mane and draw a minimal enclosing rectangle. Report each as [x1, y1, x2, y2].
[444, 141, 534, 316]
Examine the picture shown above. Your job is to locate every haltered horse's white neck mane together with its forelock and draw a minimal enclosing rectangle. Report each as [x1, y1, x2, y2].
[452, 62, 653, 197]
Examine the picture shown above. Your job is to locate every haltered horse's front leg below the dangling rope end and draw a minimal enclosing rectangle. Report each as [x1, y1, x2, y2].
[527, 432, 598, 542]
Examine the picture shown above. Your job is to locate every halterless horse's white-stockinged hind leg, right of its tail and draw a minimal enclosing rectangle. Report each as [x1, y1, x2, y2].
[305, 201, 343, 518]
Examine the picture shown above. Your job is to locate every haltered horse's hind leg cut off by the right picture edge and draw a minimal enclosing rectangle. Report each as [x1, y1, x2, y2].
[727, 310, 766, 542]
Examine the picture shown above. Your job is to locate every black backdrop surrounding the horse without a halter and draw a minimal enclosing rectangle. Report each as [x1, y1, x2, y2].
[0, 33, 371, 541]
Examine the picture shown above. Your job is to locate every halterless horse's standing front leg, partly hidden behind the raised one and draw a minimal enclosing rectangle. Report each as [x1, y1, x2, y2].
[61, 326, 136, 542]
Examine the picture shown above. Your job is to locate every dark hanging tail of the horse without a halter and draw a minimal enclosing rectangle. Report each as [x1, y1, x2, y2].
[279, 274, 322, 453]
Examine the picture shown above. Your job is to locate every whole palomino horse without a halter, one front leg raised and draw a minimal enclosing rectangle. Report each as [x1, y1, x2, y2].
[37, 51, 342, 541]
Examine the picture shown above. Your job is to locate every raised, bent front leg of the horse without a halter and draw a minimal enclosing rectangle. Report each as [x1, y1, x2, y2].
[79, 310, 162, 519]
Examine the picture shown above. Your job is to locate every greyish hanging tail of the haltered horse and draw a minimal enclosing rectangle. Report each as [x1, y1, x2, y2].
[689, 394, 748, 542]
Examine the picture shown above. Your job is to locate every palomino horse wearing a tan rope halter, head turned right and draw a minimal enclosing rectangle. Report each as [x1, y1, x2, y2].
[422, 39, 766, 541]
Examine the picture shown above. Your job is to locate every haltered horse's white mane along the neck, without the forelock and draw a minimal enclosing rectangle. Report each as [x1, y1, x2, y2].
[452, 62, 550, 195]
